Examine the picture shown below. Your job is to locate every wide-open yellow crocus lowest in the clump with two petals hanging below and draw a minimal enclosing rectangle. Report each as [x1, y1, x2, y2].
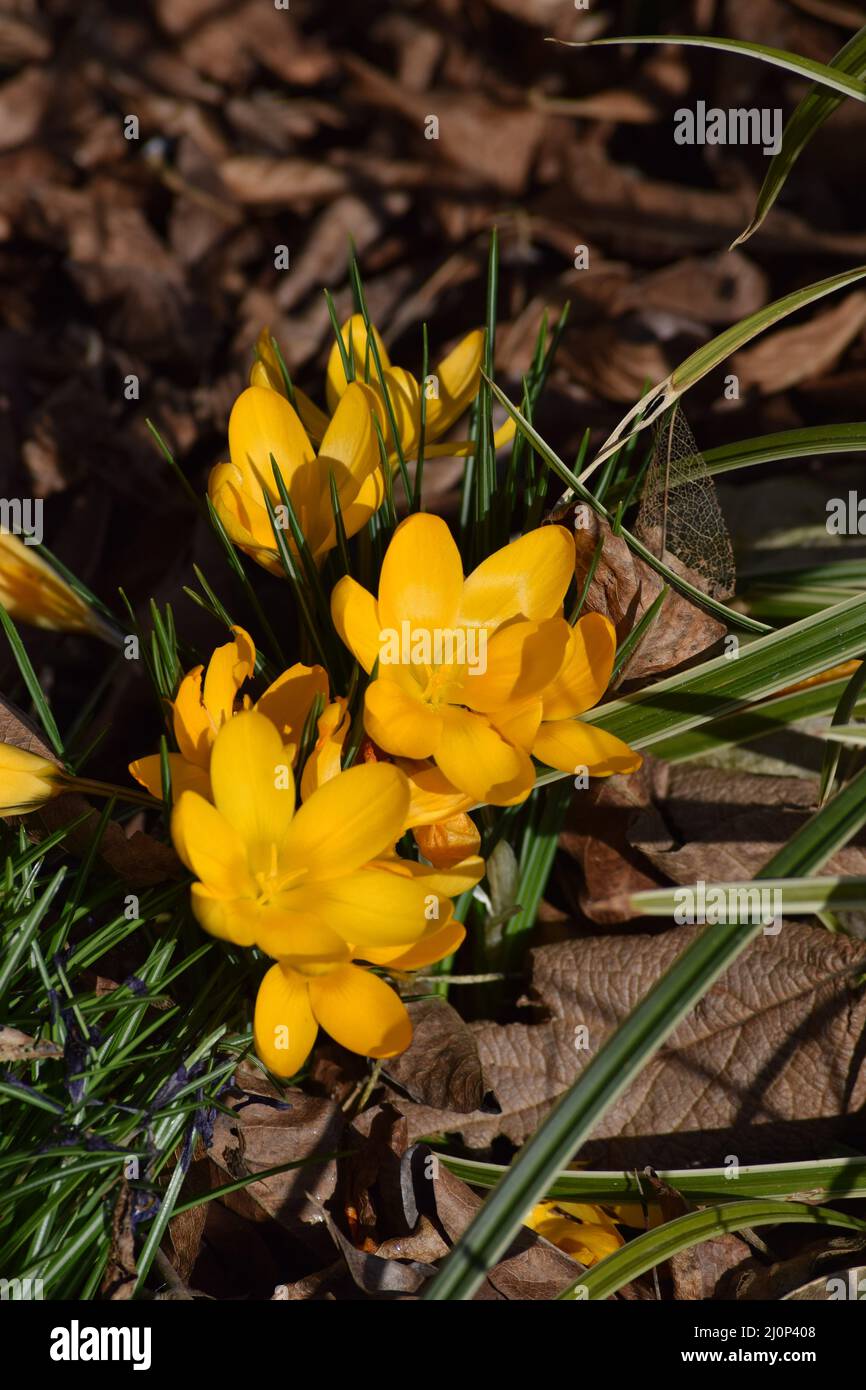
[171, 710, 461, 1076]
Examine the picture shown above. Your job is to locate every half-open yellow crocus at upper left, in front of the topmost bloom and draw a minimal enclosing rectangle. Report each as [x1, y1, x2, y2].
[207, 382, 385, 574]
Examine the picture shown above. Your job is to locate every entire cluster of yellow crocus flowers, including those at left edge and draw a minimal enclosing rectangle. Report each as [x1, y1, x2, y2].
[0, 304, 639, 1084]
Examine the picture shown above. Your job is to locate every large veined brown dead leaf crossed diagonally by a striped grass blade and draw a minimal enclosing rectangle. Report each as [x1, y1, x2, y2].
[395, 923, 866, 1168]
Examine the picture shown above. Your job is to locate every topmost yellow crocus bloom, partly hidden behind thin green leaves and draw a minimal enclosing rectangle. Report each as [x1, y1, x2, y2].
[325, 314, 514, 461]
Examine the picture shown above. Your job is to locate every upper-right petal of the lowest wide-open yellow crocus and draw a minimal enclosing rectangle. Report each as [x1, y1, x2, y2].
[284, 763, 409, 880]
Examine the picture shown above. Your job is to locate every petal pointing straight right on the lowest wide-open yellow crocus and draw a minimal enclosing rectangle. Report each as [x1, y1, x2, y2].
[281, 861, 430, 947]
